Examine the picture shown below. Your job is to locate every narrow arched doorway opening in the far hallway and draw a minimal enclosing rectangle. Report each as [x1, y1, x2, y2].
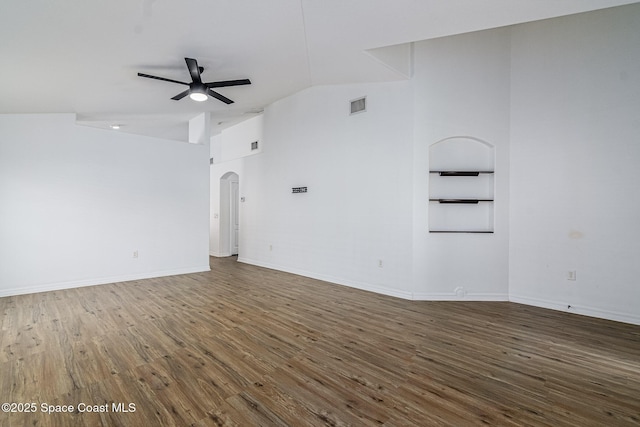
[219, 172, 240, 256]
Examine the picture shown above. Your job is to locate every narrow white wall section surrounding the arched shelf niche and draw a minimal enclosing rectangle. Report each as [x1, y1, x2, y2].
[413, 28, 511, 300]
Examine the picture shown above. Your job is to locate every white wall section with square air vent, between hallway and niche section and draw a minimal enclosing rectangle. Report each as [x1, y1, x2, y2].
[226, 82, 412, 296]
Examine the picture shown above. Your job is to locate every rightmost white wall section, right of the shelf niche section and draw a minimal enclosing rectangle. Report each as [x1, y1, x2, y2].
[509, 4, 640, 323]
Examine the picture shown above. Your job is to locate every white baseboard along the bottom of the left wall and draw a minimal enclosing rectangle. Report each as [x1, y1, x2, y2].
[0, 265, 211, 297]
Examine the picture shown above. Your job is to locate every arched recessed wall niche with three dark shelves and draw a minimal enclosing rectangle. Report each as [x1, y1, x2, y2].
[429, 136, 495, 233]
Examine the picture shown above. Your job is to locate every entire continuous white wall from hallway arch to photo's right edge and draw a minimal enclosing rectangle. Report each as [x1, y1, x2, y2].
[212, 5, 640, 324]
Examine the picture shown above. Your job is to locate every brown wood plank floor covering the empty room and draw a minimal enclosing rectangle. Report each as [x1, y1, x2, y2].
[0, 258, 640, 427]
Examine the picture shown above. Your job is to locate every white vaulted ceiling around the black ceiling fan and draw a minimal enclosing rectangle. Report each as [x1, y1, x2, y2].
[0, 0, 638, 140]
